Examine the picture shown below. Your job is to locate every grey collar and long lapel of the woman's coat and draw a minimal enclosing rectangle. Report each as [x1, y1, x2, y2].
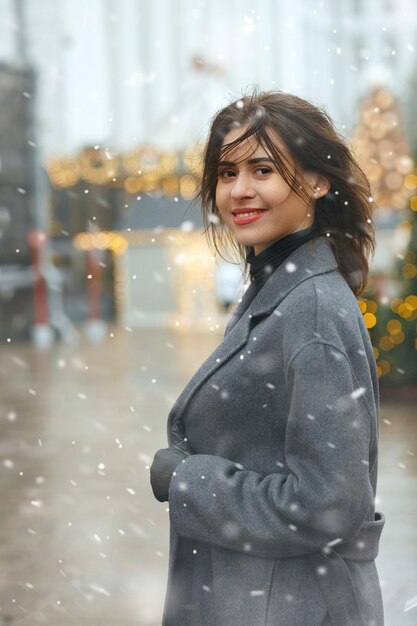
[168, 237, 337, 434]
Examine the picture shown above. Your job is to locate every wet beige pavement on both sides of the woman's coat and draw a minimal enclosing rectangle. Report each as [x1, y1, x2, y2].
[0, 329, 417, 626]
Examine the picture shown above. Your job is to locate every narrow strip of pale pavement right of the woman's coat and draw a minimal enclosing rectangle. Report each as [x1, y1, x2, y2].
[377, 403, 417, 626]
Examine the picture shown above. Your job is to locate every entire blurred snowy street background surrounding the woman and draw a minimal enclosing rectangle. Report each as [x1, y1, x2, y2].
[0, 0, 417, 626]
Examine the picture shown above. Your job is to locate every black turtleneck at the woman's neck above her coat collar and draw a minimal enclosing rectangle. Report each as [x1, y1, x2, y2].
[246, 224, 318, 291]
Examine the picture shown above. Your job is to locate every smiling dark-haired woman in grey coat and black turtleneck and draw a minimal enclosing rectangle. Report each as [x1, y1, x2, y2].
[151, 92, 384, 626]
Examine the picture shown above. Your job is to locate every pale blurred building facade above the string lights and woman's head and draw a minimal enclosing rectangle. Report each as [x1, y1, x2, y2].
[0, 0, 417, 157]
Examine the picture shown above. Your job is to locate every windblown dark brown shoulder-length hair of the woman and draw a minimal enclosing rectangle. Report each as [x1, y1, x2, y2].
[198, 91, 375, 295]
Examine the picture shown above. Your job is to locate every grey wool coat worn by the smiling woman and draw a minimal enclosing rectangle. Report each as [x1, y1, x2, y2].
[163, 237, 384, 626]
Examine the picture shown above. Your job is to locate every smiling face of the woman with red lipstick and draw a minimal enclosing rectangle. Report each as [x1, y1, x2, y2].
[216, 127, 316, 254]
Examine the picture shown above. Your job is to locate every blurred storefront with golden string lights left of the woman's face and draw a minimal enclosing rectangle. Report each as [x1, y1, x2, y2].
[47, 146, 240, 330]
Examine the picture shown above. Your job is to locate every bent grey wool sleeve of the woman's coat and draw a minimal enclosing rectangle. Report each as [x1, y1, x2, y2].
[169, 341, 375, 558]
